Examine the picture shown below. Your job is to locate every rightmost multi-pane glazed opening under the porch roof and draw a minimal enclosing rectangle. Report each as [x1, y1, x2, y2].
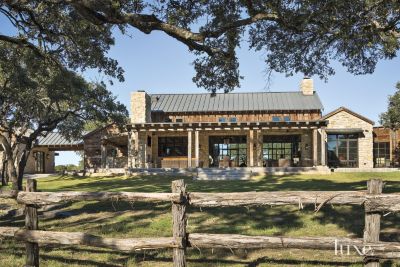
[263, 135, 300, 167]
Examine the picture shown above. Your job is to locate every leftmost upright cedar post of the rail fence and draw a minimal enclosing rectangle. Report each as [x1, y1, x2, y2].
[25, 179, 39, 267]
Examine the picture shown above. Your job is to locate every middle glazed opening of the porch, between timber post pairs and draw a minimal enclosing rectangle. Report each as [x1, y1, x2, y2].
[209, 135, 247, 168]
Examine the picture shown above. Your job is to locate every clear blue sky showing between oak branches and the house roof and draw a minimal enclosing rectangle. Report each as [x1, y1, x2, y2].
[0, 16, 400, 164]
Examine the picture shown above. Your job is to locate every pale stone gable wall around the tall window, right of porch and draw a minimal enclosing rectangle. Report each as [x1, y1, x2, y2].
[327, 111, 374, 168]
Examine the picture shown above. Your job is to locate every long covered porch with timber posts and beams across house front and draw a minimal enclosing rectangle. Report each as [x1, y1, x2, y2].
[127, 120, 327, 169]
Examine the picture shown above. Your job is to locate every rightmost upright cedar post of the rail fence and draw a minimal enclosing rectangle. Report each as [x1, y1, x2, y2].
[364, 179, 383, 267]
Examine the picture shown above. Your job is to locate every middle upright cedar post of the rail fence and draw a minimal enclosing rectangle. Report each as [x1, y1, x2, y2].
[172, 180, 187, 267]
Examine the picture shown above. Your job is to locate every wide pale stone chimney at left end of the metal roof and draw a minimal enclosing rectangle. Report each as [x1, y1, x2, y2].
[131, 91, 151, 123]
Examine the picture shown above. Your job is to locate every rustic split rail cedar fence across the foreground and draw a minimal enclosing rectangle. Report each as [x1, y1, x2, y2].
[0, 179, 400, 267]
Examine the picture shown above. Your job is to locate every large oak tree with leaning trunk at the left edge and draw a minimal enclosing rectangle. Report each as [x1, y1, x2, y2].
[0, 43, 128, 190]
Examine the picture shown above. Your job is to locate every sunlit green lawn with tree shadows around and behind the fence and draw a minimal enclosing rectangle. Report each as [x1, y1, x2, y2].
[0, 173, 400, 266]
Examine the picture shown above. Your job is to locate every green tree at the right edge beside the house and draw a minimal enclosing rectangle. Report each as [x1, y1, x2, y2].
[380, 82, 400, 130]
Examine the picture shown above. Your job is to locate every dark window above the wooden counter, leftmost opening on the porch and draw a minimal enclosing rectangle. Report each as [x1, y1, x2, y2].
[158, 137, 188, 157]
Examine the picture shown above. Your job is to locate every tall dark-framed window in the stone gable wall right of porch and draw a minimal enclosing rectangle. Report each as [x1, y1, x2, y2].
[328, 134, 358, 168]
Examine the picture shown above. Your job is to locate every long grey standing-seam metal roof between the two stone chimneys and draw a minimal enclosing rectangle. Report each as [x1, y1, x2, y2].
[151, 92, 323, 112]
